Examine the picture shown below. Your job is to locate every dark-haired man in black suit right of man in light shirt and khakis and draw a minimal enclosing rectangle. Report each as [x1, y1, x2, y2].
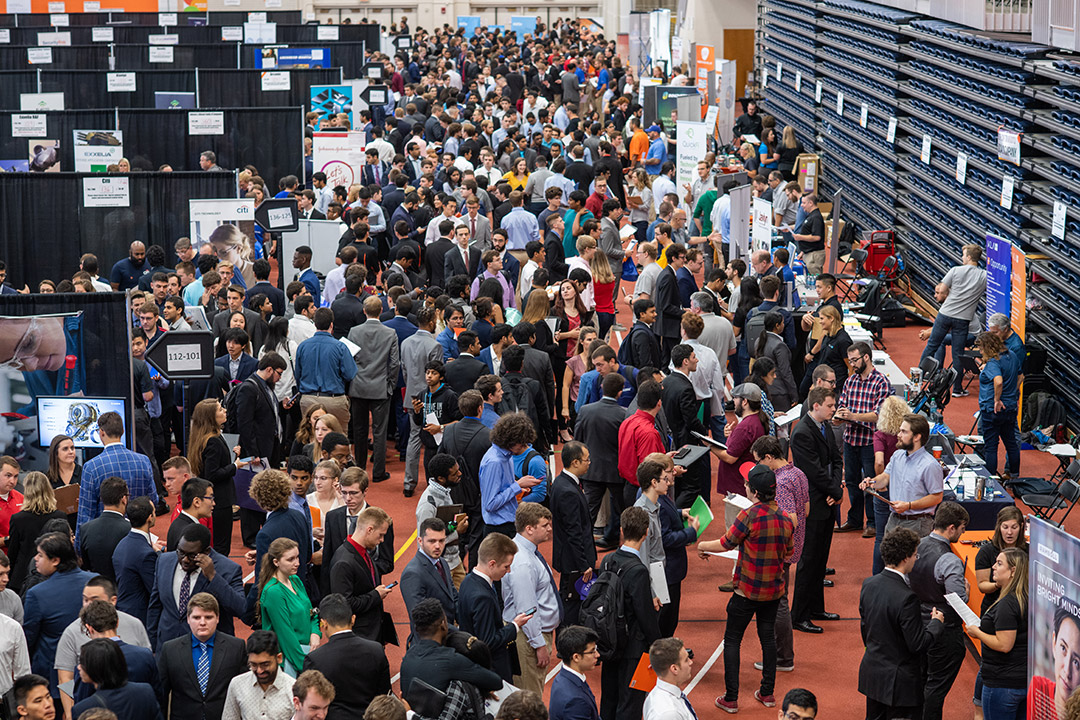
[548, 440, 596, 637]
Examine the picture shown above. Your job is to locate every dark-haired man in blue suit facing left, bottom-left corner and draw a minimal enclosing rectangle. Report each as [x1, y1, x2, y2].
[23, 532, 94, 697]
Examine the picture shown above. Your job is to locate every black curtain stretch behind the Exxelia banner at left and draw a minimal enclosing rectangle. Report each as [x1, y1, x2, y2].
[0, 107, 305, 181]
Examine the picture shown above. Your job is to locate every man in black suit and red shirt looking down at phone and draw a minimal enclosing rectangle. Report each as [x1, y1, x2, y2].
[330, 507, 397, 644]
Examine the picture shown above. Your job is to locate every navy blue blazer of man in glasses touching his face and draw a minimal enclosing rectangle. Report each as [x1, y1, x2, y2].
[145, 549, 246, 653]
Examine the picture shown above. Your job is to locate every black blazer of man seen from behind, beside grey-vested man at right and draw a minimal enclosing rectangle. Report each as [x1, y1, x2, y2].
[859, 570, 945, 707]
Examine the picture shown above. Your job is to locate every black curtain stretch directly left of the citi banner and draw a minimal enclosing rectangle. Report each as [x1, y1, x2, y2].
[0, 172, 237, 288]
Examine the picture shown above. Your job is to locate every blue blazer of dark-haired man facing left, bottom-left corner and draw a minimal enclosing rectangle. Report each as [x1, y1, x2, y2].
[23, 569, 95, 697]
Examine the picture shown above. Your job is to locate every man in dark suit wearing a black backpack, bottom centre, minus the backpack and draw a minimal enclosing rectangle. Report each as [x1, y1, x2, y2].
[600, 507, 660, 720]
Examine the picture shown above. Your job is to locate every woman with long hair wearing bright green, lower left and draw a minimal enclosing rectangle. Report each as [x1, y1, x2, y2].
[256, 538, 320, 678]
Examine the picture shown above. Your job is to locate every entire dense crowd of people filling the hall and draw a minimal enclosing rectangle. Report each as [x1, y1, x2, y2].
[0, 12, 1049, 720]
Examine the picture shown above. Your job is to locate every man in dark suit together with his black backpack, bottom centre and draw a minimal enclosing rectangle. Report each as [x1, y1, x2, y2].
[581, 507, 660, 720]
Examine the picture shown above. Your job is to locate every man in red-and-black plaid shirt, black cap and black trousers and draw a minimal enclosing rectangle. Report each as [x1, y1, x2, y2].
[698, 465, 795, 712]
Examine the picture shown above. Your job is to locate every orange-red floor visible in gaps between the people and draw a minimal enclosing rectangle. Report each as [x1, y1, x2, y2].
[243, 266, 1080, 720]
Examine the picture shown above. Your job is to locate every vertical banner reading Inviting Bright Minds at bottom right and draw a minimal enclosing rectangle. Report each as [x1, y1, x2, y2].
[1027, 515, 1080, 720]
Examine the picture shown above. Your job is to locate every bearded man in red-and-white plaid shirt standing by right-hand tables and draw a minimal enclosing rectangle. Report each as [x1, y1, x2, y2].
[833, 342, 892, 538]
